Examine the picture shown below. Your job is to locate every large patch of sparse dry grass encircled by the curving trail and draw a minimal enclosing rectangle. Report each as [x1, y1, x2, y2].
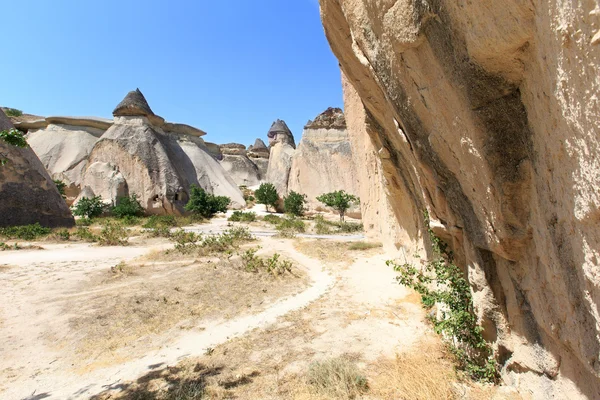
[65, 255, 307, 366]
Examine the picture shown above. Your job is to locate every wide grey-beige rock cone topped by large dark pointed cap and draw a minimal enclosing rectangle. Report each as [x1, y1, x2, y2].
[81, 90, 245, 214]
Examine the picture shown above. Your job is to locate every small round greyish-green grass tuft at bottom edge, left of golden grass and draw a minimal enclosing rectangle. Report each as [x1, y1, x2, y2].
[306, 357, 369, 399]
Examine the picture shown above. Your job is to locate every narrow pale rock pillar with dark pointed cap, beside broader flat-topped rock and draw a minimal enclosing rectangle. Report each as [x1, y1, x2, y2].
[266, 119, 296, 196]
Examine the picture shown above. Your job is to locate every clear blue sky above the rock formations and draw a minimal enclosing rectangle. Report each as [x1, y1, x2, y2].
[0, 0, 342, 144]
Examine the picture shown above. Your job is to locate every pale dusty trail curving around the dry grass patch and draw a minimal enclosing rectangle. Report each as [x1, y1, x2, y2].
[0, 233, 333, 399]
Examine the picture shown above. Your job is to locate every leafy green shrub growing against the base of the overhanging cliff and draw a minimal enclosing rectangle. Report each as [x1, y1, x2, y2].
[387, 211, 499, 383]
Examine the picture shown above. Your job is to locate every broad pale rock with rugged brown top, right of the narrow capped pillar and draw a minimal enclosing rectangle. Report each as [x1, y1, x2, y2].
[288, 108, 359, 207]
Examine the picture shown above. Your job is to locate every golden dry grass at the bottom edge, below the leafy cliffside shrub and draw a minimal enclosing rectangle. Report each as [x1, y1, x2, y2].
[369, 339, 458, 400]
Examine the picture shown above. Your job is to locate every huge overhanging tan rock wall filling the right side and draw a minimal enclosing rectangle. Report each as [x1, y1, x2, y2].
[321, 0, 600, 398]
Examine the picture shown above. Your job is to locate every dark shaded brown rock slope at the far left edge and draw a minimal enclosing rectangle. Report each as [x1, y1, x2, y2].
[0, 110, 75, 227]
